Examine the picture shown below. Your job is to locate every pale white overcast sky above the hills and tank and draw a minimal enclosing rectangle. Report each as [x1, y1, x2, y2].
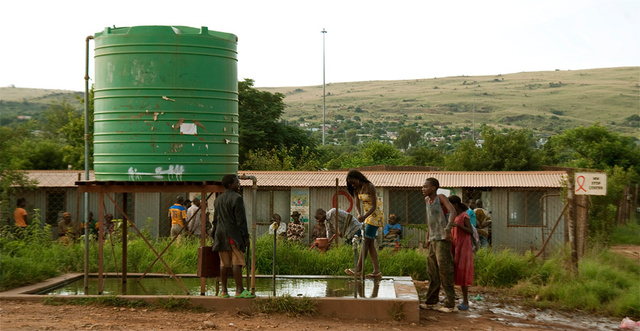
[0, 0, 640, 91]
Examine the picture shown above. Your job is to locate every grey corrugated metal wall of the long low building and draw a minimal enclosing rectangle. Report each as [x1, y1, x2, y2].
[5, 186, 564, 252]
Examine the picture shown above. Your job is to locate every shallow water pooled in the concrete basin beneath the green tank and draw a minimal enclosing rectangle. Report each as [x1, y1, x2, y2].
[37, 277, 396, 299]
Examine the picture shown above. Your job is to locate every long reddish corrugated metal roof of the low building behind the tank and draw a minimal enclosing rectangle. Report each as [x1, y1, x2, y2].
[16, 170, 567, 188]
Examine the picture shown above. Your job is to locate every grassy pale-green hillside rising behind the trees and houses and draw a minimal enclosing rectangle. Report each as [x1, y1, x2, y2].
[0, 67, 640, 138]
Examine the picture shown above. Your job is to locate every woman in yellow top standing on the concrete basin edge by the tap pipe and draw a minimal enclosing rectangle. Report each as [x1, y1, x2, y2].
[345, 170, 384, 278]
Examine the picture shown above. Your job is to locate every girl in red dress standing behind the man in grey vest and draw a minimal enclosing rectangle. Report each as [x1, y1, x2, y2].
[449, 195, 473, 310]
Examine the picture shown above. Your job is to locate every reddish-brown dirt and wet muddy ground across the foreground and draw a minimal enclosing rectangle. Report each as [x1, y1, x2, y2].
[0, 246, 640, 331]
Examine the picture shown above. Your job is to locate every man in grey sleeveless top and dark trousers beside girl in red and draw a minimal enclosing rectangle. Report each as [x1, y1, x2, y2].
[420, 177, 457, 313]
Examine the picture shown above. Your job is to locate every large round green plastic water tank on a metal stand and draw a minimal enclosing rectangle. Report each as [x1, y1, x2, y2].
[93, 26, 238, 181]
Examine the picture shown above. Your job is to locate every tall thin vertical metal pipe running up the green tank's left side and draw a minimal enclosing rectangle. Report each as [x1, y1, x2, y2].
[84, 36, 93, 295]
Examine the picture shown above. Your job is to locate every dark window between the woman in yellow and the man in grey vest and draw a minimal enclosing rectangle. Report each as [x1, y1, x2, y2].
[389, 189, 427, 224]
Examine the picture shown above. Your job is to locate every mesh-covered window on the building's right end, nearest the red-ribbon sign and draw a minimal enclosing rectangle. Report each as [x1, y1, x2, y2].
[508, 191, 545, 226]
